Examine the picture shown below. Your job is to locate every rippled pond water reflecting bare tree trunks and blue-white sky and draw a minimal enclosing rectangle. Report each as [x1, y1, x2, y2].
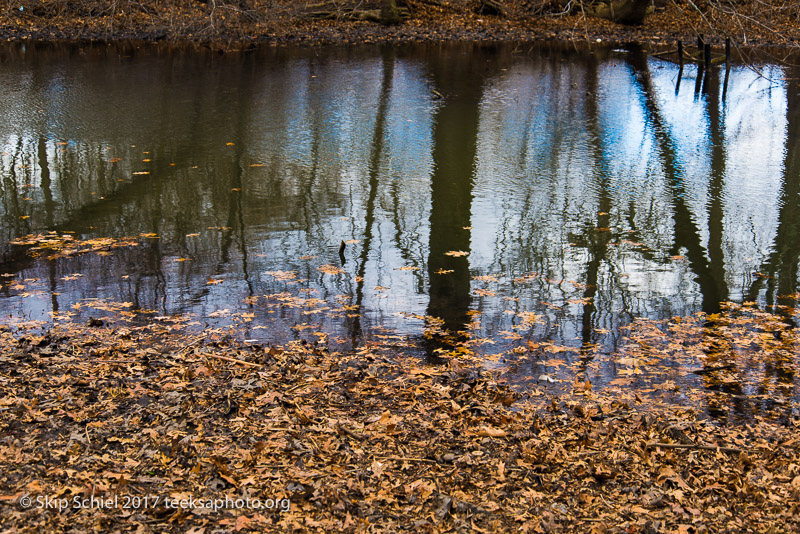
[0, 44, 800, 414]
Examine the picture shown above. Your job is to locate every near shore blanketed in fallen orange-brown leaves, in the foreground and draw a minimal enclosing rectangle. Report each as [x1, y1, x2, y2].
[0, 312, 800, 533]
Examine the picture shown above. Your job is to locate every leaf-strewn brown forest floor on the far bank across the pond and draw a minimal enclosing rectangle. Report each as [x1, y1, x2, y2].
[0, 0, 800, 50]
